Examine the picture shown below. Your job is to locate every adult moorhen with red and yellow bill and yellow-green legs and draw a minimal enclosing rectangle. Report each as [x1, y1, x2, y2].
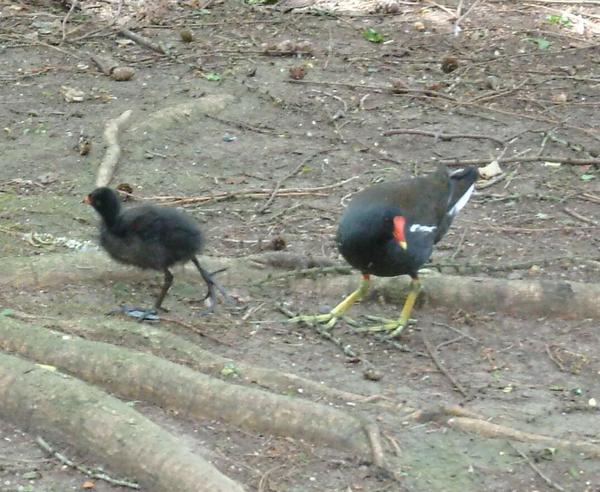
[290, 167, 479, 337]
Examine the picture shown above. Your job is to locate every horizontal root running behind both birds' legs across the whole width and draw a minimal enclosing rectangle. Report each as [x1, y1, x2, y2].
[0, 253, 600, 319]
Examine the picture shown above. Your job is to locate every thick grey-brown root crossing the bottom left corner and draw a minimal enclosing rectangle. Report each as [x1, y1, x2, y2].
[0, 353, 243, 492]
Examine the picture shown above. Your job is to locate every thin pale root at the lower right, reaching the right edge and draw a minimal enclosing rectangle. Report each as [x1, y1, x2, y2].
[447, 417, 600, 458]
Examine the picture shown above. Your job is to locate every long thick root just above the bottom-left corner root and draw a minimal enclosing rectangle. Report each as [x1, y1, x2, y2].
[0, 317, 381, 465]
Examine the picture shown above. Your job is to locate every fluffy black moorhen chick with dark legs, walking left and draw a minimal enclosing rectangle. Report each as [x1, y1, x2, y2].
[83, 187, 228, 320]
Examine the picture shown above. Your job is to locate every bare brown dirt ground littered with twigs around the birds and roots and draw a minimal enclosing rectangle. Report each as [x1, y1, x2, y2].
[0, 0, 600, 492]
